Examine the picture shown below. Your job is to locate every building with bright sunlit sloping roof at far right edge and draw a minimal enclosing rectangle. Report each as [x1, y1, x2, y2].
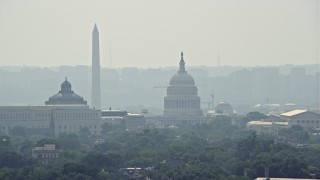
[281, 110, 320, 128]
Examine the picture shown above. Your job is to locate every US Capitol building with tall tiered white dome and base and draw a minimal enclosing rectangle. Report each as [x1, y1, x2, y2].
[147, 52, 206, 127]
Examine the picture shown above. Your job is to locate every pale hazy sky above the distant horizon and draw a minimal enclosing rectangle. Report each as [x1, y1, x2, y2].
[0, 0, 319, 67]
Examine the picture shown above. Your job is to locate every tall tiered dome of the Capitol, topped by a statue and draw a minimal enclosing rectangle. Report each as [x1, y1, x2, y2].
[163, 52, 202, 116]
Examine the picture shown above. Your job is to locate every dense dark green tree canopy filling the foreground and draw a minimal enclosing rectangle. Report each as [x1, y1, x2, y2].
[0, 114, 320, 180]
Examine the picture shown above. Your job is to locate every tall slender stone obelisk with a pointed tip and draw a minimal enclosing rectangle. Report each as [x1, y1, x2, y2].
[91, 24, 101, 109]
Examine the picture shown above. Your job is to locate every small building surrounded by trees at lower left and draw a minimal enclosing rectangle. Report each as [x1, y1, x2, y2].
[32, 144, 63, 164]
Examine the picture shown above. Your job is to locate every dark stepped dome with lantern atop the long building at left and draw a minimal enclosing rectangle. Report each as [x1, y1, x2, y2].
[45, 77, 87, 105]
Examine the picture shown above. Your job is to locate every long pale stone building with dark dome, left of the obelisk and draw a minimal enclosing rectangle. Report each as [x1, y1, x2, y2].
[0, 78, 102, 137]
